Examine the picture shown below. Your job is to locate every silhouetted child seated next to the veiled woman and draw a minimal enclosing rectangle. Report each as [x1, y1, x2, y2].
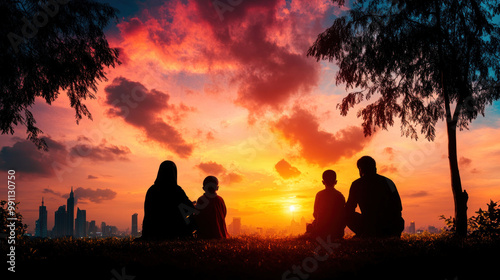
[194, 176, 229, 239]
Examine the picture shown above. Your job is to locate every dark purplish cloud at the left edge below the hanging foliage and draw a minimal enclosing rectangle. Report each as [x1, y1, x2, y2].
[0, 137, 68, 177]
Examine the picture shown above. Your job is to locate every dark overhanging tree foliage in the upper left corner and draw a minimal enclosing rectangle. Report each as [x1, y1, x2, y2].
[0, 0, 120, 150]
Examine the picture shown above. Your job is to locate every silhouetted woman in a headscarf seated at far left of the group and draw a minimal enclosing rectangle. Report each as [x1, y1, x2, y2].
[141, 160, 194, 241]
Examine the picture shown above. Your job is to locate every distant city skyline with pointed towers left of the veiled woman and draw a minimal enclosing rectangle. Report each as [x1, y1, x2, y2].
[35, 188, 140, 238]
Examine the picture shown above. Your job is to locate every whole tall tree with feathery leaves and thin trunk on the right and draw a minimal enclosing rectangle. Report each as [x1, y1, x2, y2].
[308, 0, 500, 236]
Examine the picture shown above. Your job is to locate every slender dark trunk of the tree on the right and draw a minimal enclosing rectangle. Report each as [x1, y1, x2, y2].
[446, 121, 469, 237]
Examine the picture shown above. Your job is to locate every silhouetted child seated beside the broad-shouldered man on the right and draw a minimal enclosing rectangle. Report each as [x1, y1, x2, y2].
[308, 170, 345, 238]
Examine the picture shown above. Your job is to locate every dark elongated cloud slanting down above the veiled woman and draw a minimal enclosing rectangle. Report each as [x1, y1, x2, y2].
[104, 77, 193, 158]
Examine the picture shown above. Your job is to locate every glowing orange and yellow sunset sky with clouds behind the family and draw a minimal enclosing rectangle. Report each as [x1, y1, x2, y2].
[0, 0, 500, 232]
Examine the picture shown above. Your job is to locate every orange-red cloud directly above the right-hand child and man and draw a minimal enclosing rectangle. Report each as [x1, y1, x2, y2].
[274, 107, 370, 166]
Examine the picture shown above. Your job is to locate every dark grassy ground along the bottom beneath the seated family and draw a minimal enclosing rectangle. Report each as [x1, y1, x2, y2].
[0, 235, 500, 280]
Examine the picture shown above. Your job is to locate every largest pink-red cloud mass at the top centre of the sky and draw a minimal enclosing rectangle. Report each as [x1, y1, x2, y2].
[113, 0, 332, 121]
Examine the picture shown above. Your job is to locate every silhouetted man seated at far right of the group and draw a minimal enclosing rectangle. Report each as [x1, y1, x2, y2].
[345, 156, 404, 237]
